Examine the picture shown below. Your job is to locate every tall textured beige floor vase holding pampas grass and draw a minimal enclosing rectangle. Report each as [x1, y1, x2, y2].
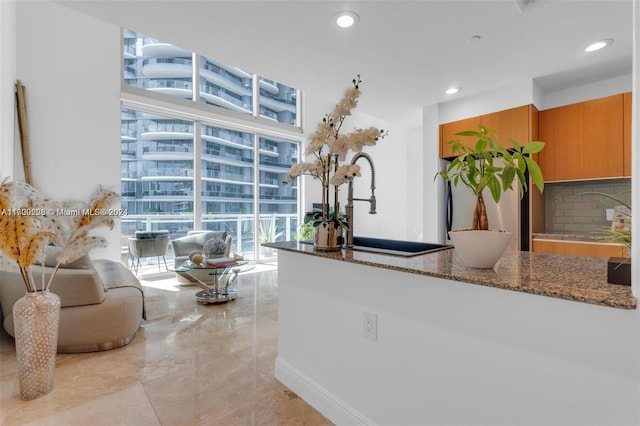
[13, 290, 60, 401]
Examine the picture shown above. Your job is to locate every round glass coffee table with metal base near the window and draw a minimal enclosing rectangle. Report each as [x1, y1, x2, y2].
[174, 259, 255, 305]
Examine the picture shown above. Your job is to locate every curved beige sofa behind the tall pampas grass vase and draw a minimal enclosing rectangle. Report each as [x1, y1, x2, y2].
[0, 247, 144, 353]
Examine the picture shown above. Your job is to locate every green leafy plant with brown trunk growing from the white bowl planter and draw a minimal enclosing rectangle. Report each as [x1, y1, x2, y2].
[434, 125, 544, 230]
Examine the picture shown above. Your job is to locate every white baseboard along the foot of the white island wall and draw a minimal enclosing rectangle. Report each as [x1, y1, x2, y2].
[275, 358, 375, 426]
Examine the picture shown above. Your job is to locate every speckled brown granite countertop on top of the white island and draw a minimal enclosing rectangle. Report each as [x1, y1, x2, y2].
[263, 241, 637, 309]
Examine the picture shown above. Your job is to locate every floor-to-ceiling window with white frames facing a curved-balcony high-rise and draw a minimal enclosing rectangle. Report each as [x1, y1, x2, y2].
[121, 30, 301, 266]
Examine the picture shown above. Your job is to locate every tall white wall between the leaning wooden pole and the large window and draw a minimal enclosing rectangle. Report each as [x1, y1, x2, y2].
[15, 2, 121, 260]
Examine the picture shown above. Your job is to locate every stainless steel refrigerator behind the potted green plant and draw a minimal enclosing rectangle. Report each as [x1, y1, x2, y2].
[445, 161, 529, 250]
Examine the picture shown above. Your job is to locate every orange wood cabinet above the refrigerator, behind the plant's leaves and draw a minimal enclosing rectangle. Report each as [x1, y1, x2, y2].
[440, 105, 538, 158]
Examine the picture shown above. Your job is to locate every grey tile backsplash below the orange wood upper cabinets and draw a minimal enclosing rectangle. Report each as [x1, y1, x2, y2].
[544, 179, 631, 237]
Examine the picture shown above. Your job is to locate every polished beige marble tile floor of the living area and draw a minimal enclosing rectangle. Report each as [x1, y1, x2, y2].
[0, 265, 331, 426]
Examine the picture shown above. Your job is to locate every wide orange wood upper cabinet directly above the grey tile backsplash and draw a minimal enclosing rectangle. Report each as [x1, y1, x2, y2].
[539, 94, 631, 181]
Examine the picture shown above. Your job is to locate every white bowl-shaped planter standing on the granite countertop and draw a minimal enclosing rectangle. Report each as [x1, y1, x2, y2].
[449, 229, 513, 269]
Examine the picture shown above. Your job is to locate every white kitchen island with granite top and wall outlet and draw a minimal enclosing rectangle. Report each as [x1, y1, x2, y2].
[268, 242, 640, 425]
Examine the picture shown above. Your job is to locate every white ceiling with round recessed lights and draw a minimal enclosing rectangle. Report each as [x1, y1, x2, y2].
[56, 0, 633, 125]
